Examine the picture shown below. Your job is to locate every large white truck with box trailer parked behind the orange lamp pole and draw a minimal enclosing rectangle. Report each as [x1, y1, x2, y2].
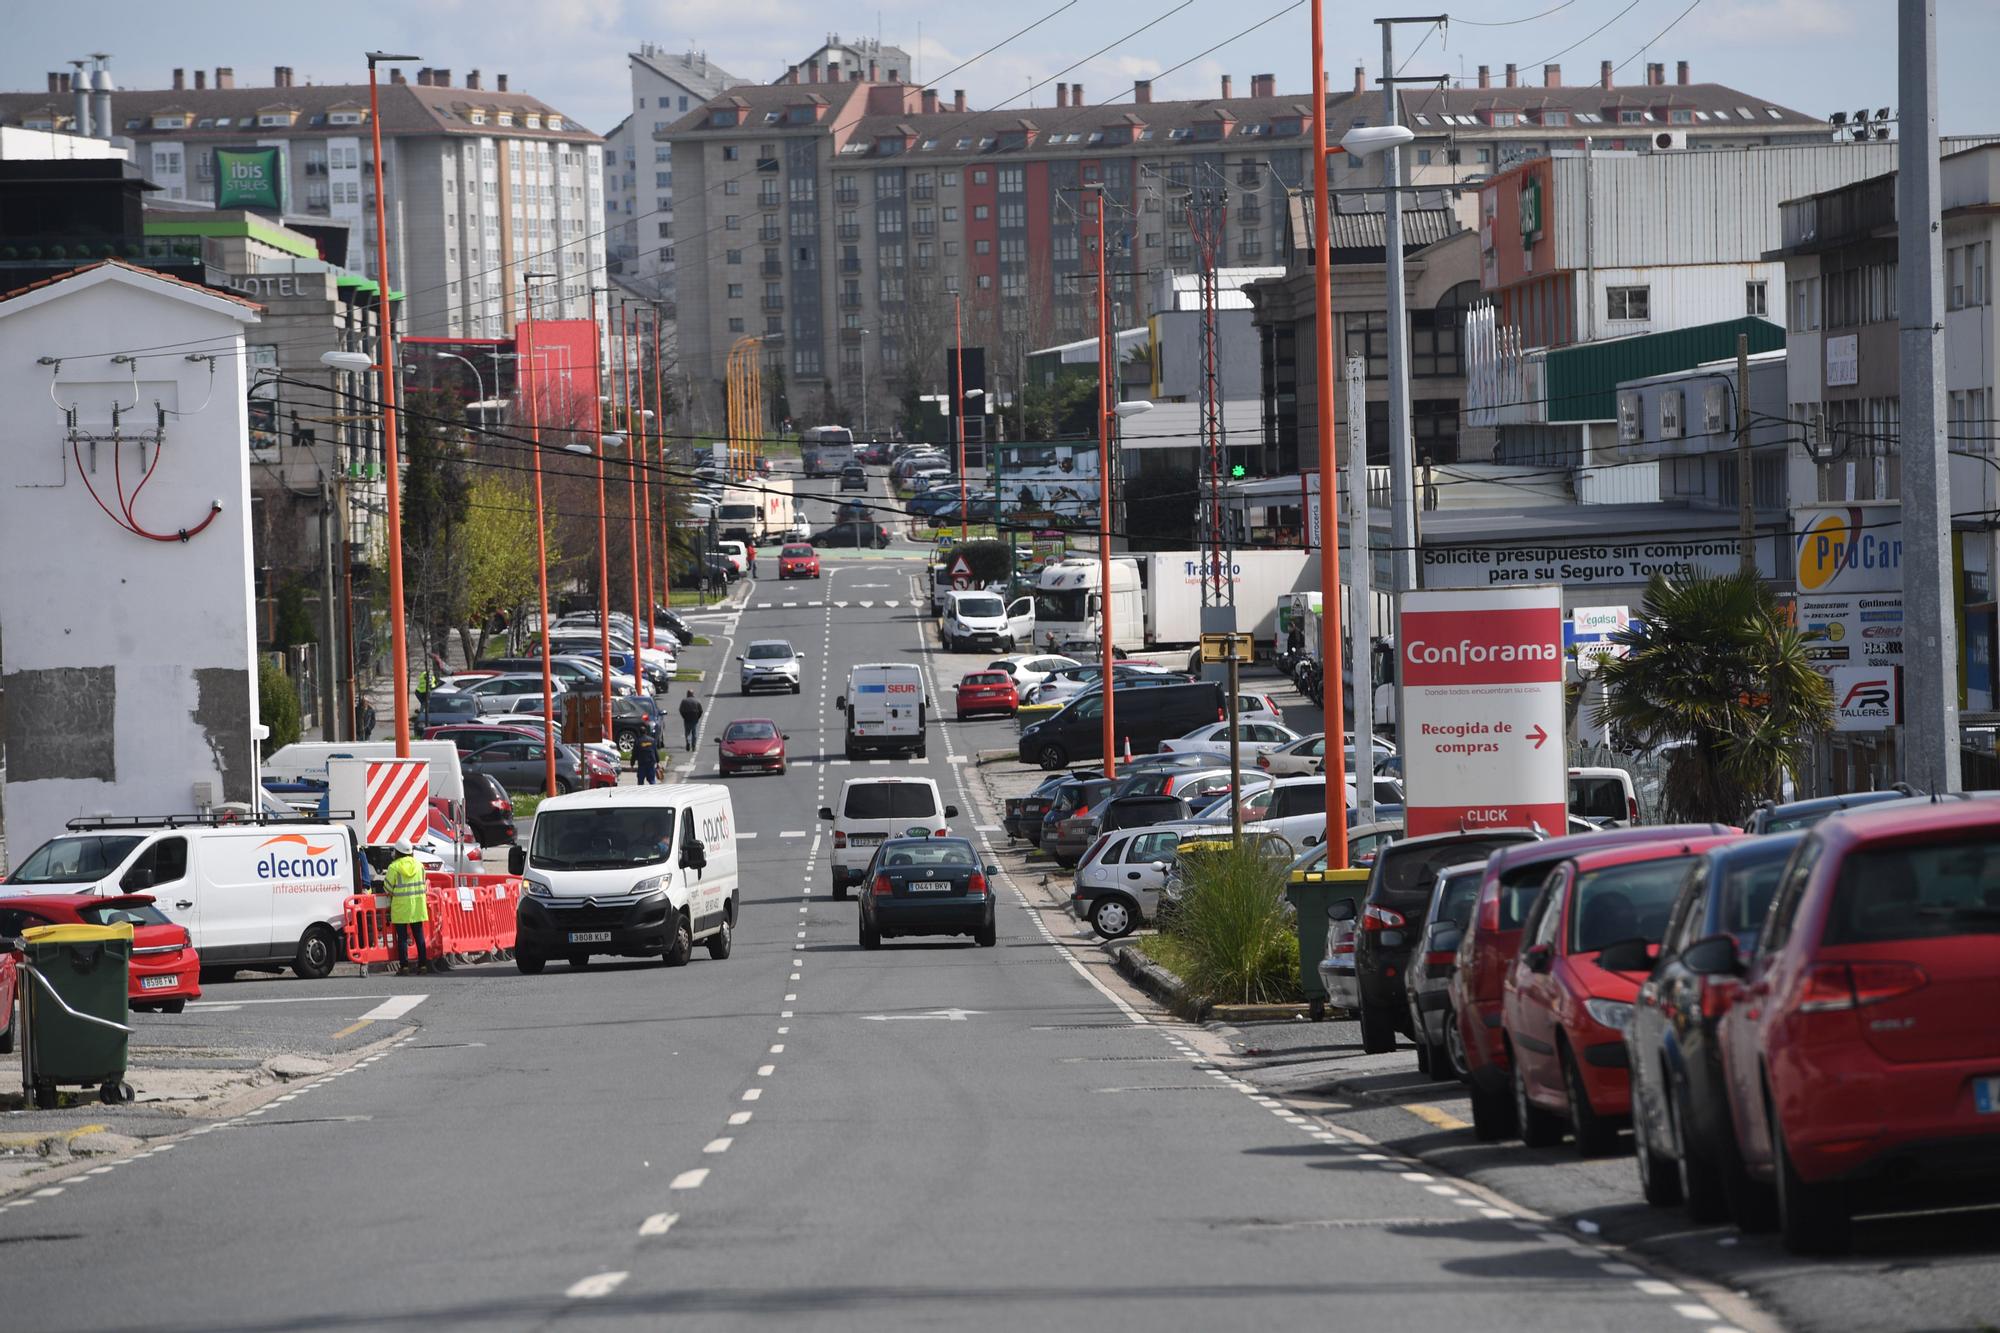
[1034, 550, 1318, 650]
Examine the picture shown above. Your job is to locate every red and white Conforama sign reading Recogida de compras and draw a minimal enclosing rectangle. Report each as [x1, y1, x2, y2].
[1396, 584, 1568, 837]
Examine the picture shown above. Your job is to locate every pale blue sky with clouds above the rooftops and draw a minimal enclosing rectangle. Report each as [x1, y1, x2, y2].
[11, 0, 2000, 134]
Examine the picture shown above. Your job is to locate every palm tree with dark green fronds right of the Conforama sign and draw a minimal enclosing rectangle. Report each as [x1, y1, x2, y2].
[1598, 574, 1834, 825]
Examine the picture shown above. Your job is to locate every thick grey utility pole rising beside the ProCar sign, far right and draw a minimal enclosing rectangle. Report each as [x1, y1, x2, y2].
[1896, 0, 1960, 791]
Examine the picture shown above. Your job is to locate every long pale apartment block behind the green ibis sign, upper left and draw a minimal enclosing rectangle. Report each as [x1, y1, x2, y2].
[0, 66, 604, 336]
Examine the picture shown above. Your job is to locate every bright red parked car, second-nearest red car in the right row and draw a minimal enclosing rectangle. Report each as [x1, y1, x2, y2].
[1500, 835, 1736, 1155]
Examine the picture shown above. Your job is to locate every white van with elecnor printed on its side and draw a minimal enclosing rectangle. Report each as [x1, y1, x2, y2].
[6, 817, 360, 979]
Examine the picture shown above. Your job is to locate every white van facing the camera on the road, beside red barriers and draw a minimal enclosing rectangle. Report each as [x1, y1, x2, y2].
[508, 783, 740, 975]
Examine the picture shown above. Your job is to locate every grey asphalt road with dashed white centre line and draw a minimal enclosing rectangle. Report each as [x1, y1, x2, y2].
[0, 474, 1758, 1333]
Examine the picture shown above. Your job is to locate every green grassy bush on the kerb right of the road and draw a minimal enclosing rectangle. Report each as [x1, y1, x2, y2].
[1170, 847, 1298, 1005]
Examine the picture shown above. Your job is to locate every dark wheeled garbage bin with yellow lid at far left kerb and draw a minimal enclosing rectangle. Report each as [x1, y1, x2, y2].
[20, 923, 132, 1109]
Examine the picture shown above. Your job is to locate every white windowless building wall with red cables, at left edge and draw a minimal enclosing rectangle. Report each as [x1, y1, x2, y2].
[0, 260, 258, 861]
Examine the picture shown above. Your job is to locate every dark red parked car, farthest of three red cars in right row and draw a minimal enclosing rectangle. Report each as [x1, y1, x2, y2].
[1446, 825, 1736, 1143]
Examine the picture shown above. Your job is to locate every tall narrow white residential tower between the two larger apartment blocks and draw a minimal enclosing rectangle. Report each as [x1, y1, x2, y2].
[604, 42, 744, 304]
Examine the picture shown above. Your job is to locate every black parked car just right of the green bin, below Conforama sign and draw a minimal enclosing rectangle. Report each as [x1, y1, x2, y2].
[1354, 829, 1542, 1055]
